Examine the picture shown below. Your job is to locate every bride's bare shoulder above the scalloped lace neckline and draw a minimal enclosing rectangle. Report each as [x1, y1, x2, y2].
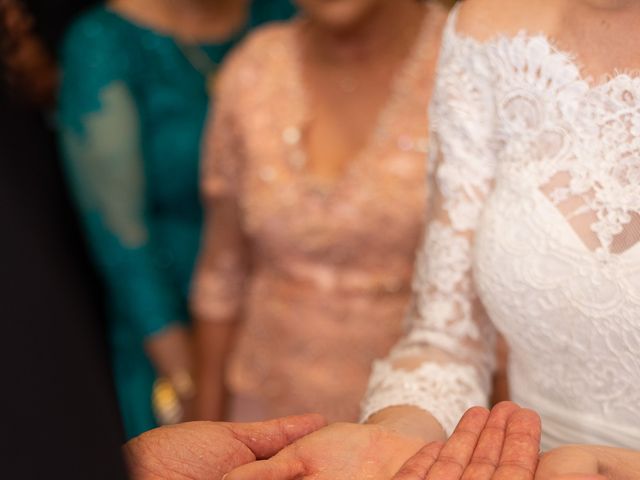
[454, 0, 557, 42]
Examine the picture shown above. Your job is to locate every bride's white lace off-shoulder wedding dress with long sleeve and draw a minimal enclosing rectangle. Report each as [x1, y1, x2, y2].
[363, 7, 640, 449]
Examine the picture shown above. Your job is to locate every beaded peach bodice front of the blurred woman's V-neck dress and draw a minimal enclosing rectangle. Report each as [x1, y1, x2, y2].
[230, 69, 428, 251]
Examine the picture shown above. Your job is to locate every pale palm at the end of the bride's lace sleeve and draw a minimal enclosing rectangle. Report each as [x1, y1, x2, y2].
[225, 423, 424, 480]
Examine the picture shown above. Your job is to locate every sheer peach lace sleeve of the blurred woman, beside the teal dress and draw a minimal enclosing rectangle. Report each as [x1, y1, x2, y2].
[191, 53, 247, 321]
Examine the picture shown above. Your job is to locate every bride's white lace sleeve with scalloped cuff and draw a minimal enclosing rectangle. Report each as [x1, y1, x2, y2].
[362, 17, 495, 433]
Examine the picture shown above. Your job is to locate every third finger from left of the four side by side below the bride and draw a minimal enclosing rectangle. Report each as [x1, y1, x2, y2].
[462, 402, 524, 480]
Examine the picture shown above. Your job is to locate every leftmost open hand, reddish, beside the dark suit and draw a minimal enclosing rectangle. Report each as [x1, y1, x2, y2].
[123, 415, 326, 480]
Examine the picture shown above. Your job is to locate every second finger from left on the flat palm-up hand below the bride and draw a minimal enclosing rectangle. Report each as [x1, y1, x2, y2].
[426, 407, 489, 480]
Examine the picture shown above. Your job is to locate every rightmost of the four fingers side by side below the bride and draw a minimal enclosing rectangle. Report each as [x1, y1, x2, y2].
[492, 408, 542, 480]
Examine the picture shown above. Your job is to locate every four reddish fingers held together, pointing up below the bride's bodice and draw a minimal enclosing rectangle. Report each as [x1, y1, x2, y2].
[393, 402, 544, 480]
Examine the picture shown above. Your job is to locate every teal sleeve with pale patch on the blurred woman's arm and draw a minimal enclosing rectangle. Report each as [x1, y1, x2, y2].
[58, 16, 182, 336]
